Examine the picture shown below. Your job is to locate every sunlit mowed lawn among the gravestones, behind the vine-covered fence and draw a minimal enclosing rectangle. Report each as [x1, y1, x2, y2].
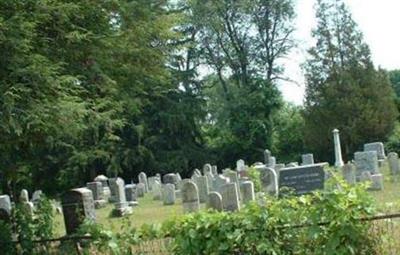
[55, 163, 400, 236]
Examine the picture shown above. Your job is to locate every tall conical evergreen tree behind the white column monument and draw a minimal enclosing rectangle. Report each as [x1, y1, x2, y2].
[304, 0, 397, 161]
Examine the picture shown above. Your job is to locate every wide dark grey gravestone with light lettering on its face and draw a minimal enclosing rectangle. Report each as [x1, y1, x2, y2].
[279, 163, 326, 195]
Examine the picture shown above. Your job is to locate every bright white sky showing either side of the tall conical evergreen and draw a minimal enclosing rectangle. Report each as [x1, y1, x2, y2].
[279, 0, 400, 105]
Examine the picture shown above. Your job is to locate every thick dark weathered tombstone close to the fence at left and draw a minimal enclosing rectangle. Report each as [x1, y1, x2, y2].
[61, 188, 96, 235]
